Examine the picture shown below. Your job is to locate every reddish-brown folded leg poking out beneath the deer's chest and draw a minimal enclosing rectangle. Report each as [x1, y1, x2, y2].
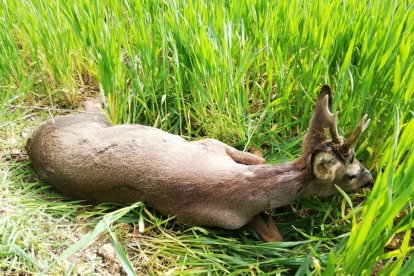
[247, 214, 283, 242]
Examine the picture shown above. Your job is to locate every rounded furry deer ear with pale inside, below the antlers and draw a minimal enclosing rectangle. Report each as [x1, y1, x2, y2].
[312, 152, 341, 181]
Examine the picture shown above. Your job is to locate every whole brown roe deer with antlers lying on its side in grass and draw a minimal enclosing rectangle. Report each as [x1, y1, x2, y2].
[26, 85, 372, 241]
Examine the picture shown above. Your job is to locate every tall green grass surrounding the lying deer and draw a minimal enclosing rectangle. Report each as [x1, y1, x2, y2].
[0, 0, 414, 275]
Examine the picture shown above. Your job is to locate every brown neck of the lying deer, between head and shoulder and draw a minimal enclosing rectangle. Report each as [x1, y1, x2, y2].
[243, 158, 310, 212]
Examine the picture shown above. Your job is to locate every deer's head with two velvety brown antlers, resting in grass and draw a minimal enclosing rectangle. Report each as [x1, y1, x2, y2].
[301, 85, 372, 196]
